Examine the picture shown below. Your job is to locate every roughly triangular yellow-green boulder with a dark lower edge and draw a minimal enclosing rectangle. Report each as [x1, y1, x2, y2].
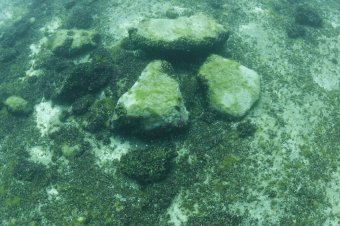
[115, 60, 189, 133]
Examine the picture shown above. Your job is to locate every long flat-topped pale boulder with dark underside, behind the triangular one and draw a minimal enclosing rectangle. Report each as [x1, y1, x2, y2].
[130, 14, 227, 56]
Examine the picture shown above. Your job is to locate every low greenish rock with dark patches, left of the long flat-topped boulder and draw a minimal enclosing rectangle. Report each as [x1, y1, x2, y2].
[48, 29, 99, 57]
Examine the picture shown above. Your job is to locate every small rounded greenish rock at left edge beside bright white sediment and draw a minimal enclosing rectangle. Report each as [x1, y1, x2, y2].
[4, 96, 32, 115]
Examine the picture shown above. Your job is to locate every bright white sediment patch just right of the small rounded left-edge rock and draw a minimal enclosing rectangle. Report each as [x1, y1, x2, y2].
[34, 101, 62, 136]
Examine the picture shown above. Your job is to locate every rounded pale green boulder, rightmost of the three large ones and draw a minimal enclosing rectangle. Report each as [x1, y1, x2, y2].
[198, 55, 260, 117]
